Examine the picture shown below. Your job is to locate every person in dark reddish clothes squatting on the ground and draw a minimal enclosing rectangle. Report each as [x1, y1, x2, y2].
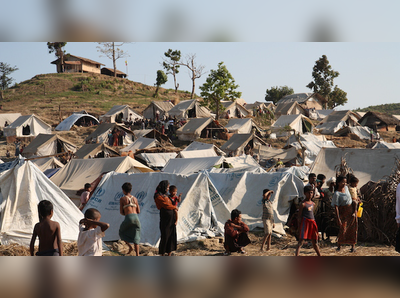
[224, 209, 251, 255]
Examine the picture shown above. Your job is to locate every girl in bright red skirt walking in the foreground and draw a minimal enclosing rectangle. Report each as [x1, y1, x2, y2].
[296, 185, 321, 256]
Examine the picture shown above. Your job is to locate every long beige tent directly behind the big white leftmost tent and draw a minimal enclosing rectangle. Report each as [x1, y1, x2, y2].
[51, 156, 153, 198]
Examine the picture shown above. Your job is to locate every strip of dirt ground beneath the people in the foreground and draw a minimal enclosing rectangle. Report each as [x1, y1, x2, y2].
[0, 232, 398, 257]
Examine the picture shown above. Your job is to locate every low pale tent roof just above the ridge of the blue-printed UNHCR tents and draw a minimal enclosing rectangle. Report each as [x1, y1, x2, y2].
[163, 156, 224, 175]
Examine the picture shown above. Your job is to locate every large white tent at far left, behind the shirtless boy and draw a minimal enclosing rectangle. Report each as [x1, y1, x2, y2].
[0, 160, 83, 246]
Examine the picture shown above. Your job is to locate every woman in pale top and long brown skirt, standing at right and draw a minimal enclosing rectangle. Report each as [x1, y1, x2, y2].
[332, 176, 357, 252]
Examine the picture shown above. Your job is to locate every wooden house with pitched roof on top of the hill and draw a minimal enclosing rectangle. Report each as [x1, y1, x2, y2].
[51, 54, 104, 74]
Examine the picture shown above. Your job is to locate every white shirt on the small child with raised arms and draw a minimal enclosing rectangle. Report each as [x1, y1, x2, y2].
[78, 225, 105, 256]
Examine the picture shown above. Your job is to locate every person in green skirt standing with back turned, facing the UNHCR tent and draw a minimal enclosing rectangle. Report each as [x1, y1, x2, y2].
[119, 182, 141, 256]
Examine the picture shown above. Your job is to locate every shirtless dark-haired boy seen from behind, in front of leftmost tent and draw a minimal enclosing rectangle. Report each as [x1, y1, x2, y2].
[30, 200, 63, 256]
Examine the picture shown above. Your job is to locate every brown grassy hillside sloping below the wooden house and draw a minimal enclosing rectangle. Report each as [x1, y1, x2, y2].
[2, 73, 194, 124]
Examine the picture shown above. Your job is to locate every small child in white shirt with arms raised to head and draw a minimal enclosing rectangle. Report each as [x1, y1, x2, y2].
[78, 208, 110, 256]
